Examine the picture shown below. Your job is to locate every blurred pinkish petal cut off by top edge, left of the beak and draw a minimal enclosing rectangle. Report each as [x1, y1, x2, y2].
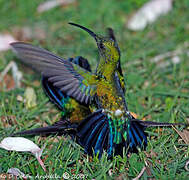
[37, 0, 75, 13]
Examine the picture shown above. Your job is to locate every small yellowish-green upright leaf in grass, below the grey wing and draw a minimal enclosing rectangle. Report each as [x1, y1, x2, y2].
[24, 87, 37, 109]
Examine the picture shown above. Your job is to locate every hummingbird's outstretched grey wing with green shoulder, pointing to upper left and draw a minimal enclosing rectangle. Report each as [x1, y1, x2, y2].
[11, 42, 97, 104]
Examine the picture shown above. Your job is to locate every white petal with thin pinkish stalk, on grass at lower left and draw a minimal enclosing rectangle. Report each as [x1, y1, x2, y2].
[0, 137, 46, 171]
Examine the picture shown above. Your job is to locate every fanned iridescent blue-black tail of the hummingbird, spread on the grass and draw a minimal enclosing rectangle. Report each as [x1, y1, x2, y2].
[76, 110, 147, 158]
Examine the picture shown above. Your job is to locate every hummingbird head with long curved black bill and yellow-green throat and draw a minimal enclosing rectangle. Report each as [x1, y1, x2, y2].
[69, 23, 120, 62]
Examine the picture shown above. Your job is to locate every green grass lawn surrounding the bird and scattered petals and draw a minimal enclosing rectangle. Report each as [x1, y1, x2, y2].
[0, 0, 189, 179]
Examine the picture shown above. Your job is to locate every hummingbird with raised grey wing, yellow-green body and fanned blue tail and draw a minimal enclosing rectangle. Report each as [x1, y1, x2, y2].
[11, 23, 185, 158]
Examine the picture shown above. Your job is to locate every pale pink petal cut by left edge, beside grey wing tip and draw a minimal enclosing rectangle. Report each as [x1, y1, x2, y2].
[0, 34, 17, 51]
